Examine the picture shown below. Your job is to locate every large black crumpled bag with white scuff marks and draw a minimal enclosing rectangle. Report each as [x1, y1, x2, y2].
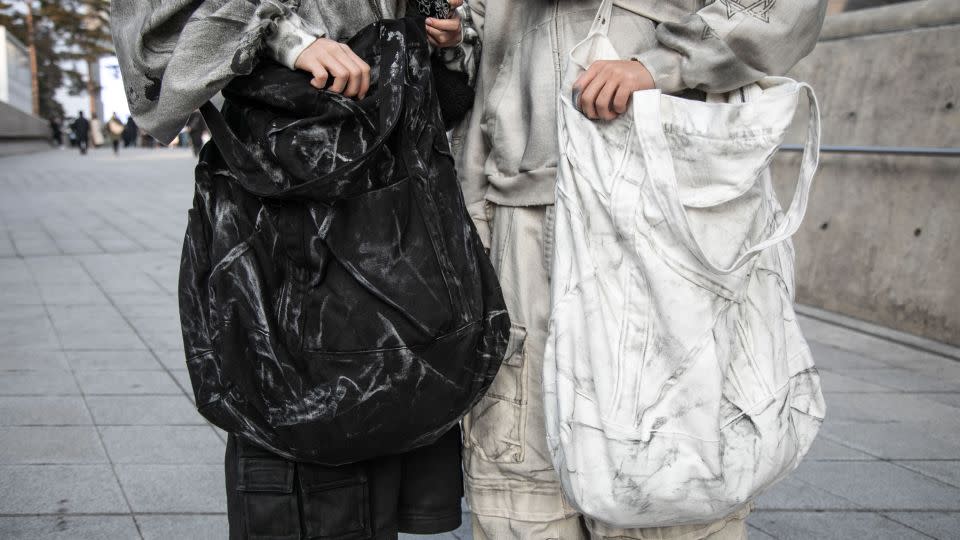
[179, 19, 510, 465]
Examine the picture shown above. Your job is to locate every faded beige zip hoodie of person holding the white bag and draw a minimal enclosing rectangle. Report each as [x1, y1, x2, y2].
[453, 0, 827, 247]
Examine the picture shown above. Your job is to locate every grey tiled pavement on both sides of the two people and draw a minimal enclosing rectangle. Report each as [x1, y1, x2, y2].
[0, 149, 960, 540]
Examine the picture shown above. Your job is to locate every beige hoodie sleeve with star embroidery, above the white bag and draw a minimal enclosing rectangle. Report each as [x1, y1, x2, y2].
[635, 0, 827, 93]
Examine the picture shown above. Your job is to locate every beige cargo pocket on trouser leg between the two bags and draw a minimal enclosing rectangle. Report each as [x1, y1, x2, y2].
[464, 324, 527, 463]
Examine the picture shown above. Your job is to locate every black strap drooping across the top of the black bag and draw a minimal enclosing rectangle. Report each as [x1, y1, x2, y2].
[200, 20, 407, 199]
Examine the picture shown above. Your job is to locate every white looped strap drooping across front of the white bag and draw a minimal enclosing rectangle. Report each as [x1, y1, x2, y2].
[634, 83, 820, 275]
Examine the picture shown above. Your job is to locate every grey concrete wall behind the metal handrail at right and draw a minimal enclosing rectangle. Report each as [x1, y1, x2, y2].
[774, 0, 960, 345]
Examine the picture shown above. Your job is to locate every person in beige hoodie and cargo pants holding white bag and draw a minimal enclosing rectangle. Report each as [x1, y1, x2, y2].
[453, 0, 826, 540]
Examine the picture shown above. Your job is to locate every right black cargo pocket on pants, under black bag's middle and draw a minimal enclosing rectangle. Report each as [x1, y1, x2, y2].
[298, 464, 373, 540]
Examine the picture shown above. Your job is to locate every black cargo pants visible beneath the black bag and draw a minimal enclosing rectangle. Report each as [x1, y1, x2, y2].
[225, 428, 463, 540]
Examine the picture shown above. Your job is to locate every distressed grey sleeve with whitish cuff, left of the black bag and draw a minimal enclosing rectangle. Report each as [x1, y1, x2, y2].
[110, 0, 323, 142]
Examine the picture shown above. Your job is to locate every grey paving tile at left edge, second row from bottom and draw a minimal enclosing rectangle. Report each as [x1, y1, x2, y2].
[0, 465, 130, 514]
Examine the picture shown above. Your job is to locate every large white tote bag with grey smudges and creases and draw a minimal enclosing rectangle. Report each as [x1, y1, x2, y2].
[544, 0, 825, 528]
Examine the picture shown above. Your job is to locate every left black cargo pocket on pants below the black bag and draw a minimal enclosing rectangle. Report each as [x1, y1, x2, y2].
[237, 457, 300, 540]
